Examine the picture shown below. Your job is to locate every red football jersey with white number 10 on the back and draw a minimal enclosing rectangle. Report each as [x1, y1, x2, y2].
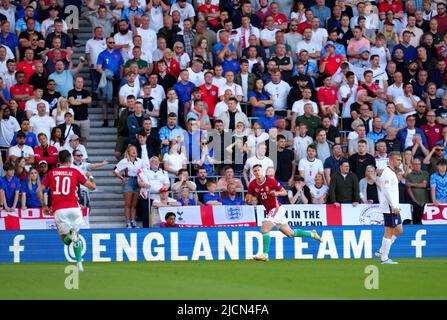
[42, 168, 87, 211]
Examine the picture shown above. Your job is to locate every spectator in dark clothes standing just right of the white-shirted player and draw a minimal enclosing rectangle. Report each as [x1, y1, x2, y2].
[405, 158, 430, 224]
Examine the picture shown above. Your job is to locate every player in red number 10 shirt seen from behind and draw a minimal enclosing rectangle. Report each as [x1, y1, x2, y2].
[37, 150, 96, 271]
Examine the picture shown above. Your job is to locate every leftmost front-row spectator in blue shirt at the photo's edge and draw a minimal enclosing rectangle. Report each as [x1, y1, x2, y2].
[0, 162, 20, 212]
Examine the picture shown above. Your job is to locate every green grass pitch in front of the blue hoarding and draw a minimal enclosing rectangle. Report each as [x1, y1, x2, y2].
[0, 258, 447, 300]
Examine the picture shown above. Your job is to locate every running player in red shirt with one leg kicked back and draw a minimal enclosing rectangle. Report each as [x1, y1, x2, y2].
[245, 164, 323, 261]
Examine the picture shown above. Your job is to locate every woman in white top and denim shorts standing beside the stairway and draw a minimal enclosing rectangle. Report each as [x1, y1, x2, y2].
[113, 145, 143, 228]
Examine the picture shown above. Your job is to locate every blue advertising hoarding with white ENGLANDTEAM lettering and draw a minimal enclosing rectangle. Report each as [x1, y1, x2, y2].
[0, 225, 447, 263]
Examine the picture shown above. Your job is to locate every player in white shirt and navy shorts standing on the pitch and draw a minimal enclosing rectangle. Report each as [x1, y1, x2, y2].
[376, 151, 403, 264]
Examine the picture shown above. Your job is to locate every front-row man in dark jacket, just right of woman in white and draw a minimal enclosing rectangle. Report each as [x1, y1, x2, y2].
[329, 160, 364, 207]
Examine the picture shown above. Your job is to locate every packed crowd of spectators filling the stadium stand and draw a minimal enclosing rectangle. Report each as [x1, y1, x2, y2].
[0, 0, 447, 228]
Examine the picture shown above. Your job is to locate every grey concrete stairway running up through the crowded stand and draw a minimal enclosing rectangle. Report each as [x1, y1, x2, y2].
[73, 14, 125, 229]
